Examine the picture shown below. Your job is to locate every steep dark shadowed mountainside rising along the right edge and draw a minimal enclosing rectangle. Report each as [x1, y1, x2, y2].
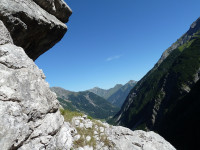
[114, 18, 200, 150]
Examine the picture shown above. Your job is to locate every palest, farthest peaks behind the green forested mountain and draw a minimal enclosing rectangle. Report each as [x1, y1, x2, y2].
[88, 84, 123, 99]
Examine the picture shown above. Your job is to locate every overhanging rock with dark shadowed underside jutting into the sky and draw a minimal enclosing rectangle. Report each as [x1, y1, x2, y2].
[0, 0, 71, 60]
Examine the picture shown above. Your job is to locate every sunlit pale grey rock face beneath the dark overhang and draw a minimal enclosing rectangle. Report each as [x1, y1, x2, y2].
[0, 44, 73, 150]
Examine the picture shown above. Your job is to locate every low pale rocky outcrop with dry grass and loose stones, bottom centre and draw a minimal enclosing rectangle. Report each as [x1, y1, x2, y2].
[65, 115, 175, 150]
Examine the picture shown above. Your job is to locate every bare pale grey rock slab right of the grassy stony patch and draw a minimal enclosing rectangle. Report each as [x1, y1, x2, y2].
[106, 126, 175, 150]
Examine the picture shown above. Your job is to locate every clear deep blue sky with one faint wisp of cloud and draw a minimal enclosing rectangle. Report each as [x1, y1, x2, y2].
[36, 0, 200, 91]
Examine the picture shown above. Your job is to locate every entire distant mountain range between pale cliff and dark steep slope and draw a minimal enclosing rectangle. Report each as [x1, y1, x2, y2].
[51, 80, 137, 120]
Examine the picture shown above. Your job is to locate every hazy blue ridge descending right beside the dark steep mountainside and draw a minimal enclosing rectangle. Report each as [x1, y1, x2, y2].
[107, 80, 137, 107]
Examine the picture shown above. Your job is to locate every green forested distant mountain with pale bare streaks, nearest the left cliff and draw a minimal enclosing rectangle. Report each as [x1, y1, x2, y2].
[51, 87, 119, 119]
